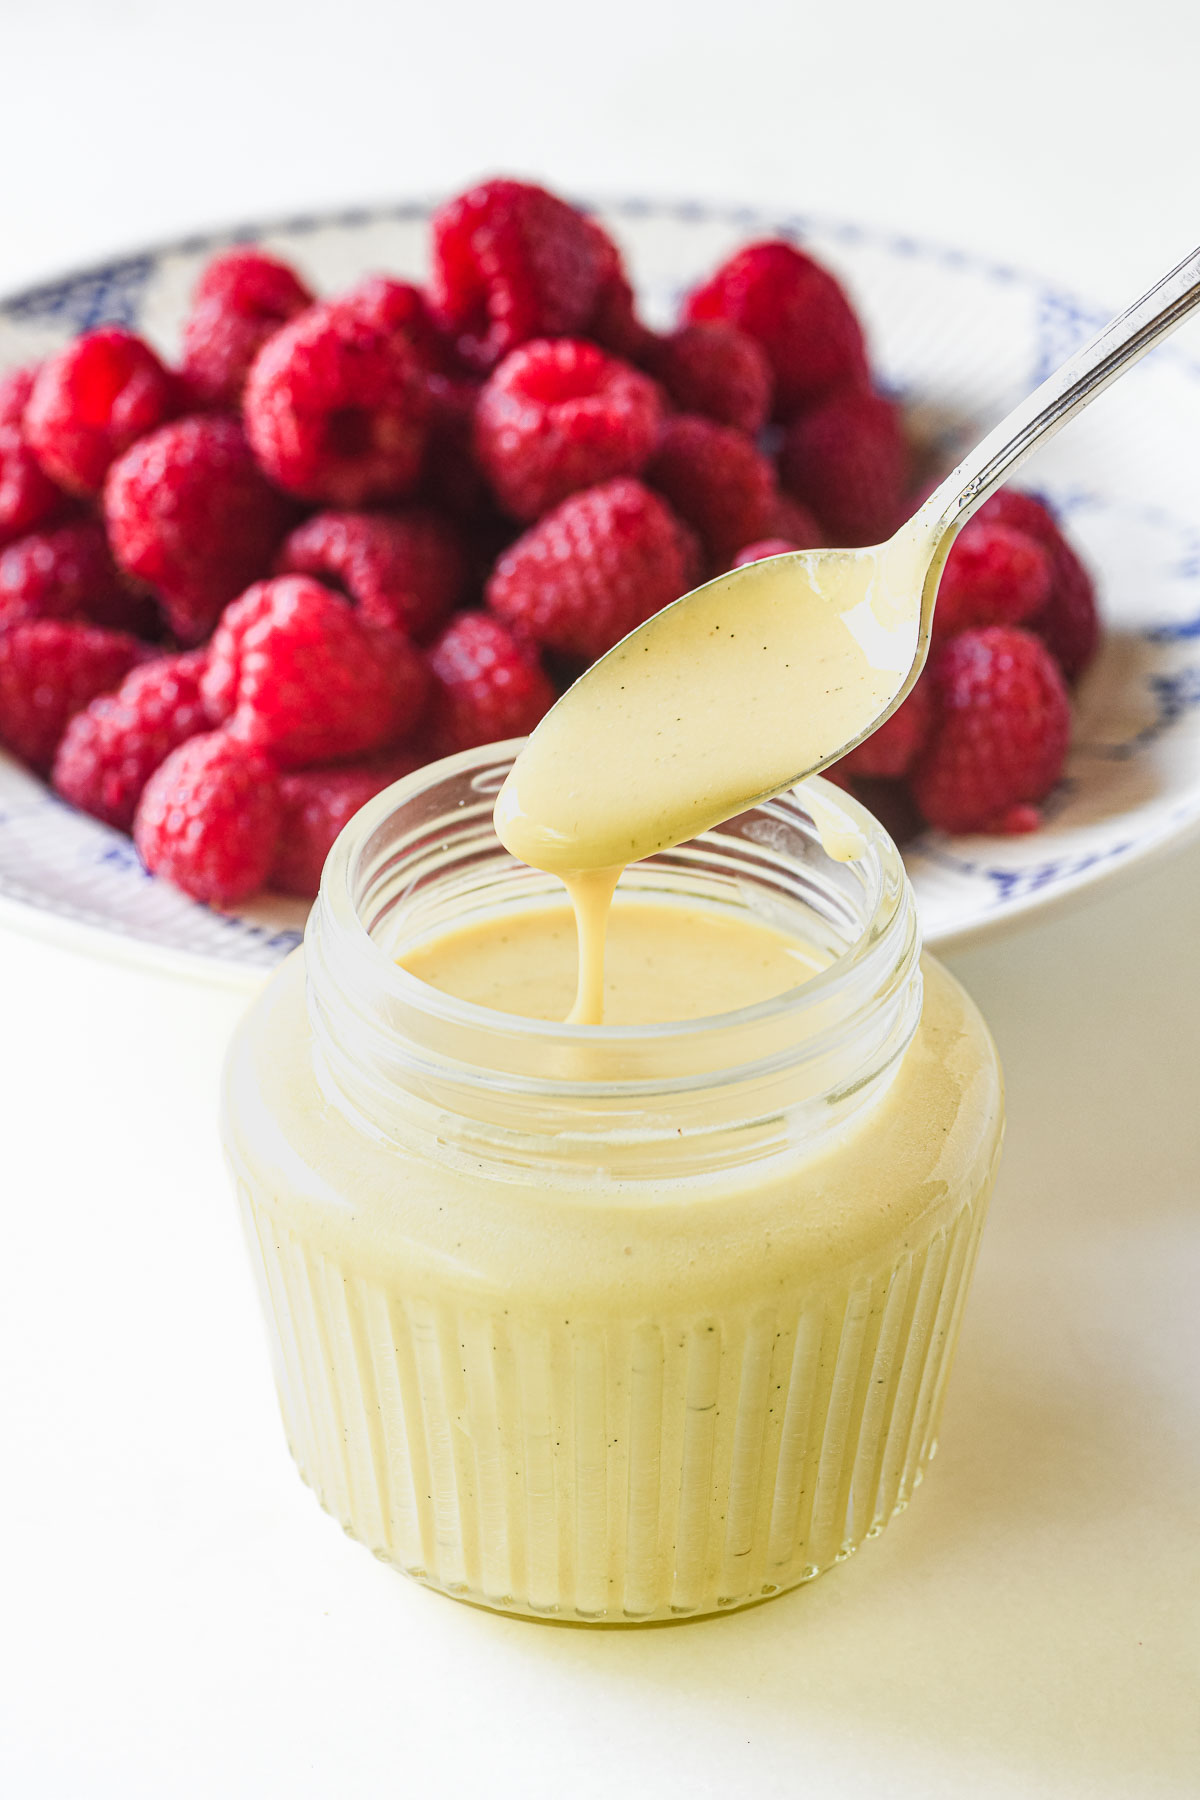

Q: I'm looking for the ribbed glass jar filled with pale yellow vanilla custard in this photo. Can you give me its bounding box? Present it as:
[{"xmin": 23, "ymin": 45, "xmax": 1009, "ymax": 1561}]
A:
[{"xmin": 223, "ymin": 745, "xmax": 1002, "ymax": 1624}]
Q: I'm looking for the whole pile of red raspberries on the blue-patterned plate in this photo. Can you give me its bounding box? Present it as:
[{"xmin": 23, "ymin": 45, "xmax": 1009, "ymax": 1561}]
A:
[{"xmin": 0, "ymin": 180, "xmax": 1097, "ymax": 905}]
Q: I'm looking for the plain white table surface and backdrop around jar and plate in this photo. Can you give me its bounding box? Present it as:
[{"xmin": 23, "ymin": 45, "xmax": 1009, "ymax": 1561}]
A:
[{"xmin": 0, "ymin": 0, "xmax": 1200, "ymax": 1800}]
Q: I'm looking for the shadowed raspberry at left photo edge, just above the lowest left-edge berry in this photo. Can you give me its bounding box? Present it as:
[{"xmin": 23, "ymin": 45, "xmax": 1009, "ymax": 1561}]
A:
[{"xmin": 0, "ymin": 518, "xmax": 143, "ymax": 630}]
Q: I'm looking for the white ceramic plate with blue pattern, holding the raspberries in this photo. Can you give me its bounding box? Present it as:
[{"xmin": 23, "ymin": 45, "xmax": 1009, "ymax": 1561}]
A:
[{"xmin": 0, "ymin": 200, "xmax": 1200, "ymax": 979}]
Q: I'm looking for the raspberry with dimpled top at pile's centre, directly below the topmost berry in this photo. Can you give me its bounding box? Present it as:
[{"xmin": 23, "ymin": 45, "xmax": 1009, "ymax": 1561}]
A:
[{"xmin": 475, "ymin": 338, "xmax": 660, "ymax": 518}]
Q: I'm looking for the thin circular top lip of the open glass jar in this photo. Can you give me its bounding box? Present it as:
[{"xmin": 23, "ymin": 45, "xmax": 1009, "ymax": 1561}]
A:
[{"xmin": 309, "ymin": 738, "xmax": 907, "ymax": 1048}]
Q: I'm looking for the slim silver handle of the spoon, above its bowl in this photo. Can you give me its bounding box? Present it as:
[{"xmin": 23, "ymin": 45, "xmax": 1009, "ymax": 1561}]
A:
[{"xmin": 923, "ymin": 250, "xmax": 1200, "ymax": 532}]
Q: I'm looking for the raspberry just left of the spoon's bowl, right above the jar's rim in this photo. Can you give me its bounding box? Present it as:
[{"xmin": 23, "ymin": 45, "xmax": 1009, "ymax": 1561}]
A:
[{"xmin": 430, "ymin": 612, "xmax": 554, "ymax": 756}]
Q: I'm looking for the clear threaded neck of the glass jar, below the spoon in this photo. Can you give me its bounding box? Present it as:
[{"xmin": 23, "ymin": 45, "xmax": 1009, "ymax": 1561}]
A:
[{"xmin": 306, "ymin": 740, "xmax": 921, "ymax": 1183}]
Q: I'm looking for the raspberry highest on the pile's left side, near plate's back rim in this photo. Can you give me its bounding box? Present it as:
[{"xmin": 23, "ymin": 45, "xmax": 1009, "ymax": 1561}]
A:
[{"xmin": 182, "ymin": 245, "xmax": 313, "ymax": 409}]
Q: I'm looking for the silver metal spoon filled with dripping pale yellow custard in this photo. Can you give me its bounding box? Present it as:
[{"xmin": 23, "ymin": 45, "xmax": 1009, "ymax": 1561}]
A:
[{"xmin": 497, "ymin": 250, "xmax": 1200, "ymax": 875}]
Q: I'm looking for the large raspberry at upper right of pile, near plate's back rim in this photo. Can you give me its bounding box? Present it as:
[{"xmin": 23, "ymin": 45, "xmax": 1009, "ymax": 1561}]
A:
[{"xmin": 684, "ymin": 241, "xmax": 867, "ymax": 419}]
